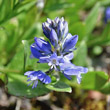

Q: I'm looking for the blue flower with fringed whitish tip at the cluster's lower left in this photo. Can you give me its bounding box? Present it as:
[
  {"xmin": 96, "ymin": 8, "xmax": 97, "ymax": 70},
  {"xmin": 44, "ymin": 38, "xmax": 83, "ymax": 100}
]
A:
[{"xmin": 24, "ymin": 71, "xmax": 51, "ymax": 88}]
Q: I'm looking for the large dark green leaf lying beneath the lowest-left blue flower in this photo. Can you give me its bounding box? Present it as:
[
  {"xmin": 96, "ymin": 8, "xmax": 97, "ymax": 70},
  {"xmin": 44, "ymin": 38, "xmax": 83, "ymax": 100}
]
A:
[{"xmin": 6, "ymin": 74, "xmax": 50, "ymax": 98}]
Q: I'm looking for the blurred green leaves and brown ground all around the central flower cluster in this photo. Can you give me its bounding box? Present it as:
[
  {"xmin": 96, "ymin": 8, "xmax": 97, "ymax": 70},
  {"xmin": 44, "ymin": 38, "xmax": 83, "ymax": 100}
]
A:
[{"xmin": 0, "ymin": 0, "xmax": 110, "ymax": 110}]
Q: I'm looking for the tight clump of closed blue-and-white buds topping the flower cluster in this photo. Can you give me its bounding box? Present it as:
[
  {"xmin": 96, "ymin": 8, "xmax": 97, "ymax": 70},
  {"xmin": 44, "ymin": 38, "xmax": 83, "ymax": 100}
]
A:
[{"xmin": 42, "ymin": 17, "xmax": 68, "ymax": 46}]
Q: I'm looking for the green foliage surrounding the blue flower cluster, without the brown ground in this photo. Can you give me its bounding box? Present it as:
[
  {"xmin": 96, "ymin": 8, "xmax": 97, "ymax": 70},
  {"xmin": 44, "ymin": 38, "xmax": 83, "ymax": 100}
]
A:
[{"xmin": 0, "ymin": 0, "xmax": 110, "ymax": 98}]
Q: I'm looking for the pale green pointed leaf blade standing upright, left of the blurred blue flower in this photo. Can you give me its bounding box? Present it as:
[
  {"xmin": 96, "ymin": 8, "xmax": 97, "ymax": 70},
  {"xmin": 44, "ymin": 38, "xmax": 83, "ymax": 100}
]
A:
[{"xmin": 85, "ymin": 2, "xmax": 100, "ymax": 35}]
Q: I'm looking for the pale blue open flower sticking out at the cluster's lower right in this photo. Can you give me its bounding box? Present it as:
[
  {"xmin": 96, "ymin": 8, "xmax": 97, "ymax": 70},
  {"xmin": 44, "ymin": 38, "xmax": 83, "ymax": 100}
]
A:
[{"xmin": 60, "ymin": 63, "xmax": 88, "ymax": 84}]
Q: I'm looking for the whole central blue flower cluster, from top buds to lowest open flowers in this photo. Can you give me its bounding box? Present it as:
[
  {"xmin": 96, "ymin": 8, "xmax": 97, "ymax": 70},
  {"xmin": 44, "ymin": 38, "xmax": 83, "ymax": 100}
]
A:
[{"xmin": 25, "ymin": 17, "xmax": 88, "ymax": 88}]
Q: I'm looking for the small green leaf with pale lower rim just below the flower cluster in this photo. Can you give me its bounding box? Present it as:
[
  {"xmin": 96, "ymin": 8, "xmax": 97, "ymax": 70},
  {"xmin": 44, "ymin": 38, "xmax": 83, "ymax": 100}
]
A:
[{"xmin": 46, "ymin": 81, "xmax": 72, "ymax": 93}]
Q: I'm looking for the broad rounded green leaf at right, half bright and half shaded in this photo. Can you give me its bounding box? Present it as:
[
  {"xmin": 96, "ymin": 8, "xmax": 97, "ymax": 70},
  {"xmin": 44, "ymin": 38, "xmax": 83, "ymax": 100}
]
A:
[{"xmin": 81, "ymin": 71, "xmax": 108, "ymax": 91}]
